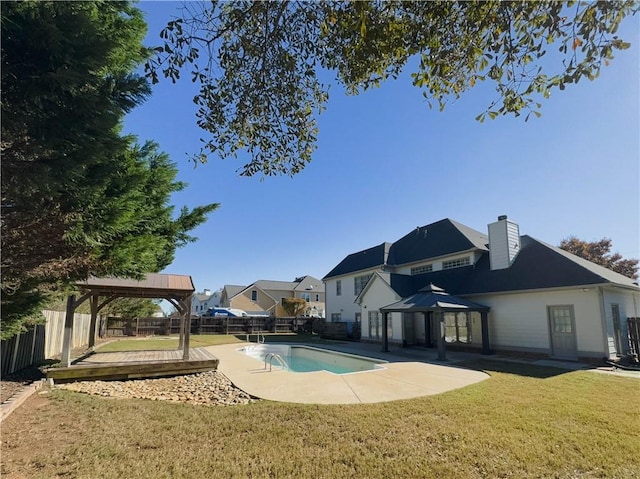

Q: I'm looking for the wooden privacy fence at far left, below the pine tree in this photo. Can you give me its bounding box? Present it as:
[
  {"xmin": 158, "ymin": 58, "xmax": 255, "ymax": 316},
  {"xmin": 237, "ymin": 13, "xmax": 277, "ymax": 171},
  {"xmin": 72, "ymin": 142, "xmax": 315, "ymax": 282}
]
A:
[{"xmin": 0, "ymin": 311, "xmax": 91, "ymax": 377}]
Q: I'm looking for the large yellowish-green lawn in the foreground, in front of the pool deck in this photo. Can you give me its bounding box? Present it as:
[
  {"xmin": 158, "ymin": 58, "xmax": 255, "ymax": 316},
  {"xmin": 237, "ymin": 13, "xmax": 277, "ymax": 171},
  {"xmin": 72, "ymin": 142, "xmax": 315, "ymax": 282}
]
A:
[{"xmin": 1, "ymin": 361, "xmax": 640, "ymax": 479}]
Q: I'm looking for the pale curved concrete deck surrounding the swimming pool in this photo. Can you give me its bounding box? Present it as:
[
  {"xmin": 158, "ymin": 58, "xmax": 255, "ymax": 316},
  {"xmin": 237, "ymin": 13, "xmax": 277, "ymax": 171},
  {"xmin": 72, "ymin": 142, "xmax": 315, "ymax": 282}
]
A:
[{"xmin": 206, "ymin": 343, "xmax": 489, "ymax": 404}]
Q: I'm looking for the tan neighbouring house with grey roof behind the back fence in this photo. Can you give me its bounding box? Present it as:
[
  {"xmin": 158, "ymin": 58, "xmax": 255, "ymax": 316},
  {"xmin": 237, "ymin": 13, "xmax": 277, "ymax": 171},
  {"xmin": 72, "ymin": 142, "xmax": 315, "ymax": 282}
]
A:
[{"xmin": 221, "ymin": 276, "xmax": 325, "ymax": 318}]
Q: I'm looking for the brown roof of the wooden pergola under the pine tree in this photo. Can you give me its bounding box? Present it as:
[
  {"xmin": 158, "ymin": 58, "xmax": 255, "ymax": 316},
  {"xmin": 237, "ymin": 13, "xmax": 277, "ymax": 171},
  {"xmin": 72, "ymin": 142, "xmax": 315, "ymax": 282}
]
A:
[{"xmin": 76, "ymin": 273, "xmax": 195, "ymax": 298}]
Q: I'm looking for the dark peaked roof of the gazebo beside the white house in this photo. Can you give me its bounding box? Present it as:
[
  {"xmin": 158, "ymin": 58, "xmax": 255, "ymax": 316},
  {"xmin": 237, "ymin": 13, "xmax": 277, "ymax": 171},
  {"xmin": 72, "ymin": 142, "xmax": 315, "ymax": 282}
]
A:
[{"xmin": 380, "ymin": 284, "xmax": 489, "ymax": 313}]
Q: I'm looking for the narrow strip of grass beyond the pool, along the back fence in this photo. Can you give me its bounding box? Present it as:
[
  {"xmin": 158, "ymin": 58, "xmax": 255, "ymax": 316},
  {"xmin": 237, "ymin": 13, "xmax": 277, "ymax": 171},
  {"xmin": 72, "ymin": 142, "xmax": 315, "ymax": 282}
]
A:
[{"xmin": 97, "ymin": 333, "xmax": 335, "ymax": 353}]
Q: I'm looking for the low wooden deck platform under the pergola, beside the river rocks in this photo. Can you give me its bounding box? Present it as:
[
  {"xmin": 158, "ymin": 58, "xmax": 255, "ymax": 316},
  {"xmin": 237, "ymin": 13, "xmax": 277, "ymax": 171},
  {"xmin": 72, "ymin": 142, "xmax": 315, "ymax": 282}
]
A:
[{"xmin": 47, "ymin": 348, "xmax": 219, "ymax": 383}]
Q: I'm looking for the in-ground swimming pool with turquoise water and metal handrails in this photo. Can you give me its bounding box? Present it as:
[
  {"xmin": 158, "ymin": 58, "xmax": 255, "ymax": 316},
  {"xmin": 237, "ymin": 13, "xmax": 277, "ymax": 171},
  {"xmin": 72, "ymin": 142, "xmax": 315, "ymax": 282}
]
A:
[{"xmin": 240, "ymin": 344, "xmax": 387, "ymax": 374}]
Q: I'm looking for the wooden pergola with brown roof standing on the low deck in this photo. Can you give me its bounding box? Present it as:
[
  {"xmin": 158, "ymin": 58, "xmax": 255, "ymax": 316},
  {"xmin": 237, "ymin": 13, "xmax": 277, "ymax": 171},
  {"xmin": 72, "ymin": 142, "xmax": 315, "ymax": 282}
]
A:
[{"xmin": 61, "ymin": 273, "xmax": 195, "ymax": 367}]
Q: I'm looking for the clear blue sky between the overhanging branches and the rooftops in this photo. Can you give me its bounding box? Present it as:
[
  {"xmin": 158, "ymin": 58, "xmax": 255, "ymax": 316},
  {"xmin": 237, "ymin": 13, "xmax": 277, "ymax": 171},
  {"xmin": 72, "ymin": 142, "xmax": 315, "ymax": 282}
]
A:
[{"xmin": 124, "ymin": 2, "xmax": 640, "ymax": 291}]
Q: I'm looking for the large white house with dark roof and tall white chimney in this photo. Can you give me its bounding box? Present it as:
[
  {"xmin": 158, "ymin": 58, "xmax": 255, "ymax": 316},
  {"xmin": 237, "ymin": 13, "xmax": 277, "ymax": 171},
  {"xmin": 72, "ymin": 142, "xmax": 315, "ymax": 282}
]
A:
[{"xmin": 323, "ymin": 216, "xmax": 640, "ymax": 359}]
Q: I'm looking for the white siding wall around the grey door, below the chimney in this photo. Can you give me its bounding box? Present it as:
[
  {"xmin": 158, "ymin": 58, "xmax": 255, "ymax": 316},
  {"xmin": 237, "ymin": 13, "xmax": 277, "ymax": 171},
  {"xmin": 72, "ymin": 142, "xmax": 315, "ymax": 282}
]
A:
[{"xmin": 470, "ymin": 288, "xmax": 606, "ymax": 357}]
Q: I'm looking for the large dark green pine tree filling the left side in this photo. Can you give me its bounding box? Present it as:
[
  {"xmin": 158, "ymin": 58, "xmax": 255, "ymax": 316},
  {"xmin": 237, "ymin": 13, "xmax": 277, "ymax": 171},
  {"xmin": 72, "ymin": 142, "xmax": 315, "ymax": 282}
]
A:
[{"xmin": 1, "ymin": 1, "xmax": 217, "ymax": 338}]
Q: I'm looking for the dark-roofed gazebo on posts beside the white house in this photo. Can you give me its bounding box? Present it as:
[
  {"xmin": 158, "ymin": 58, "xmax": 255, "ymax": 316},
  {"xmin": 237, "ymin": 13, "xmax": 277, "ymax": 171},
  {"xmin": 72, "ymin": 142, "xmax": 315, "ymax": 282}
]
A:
[{"xmin": 380, "ymin": 284, "xmax": 491, "ymax": 360}]
